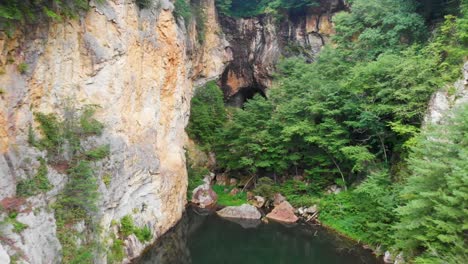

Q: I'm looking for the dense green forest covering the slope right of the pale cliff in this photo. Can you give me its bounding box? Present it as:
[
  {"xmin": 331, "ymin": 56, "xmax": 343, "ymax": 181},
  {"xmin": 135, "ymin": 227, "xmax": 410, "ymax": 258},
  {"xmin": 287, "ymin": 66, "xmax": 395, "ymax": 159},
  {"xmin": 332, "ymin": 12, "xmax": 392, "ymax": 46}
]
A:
[{"xmin": 188, "ymin": 0, "xmax": 468, "ymax": 263}]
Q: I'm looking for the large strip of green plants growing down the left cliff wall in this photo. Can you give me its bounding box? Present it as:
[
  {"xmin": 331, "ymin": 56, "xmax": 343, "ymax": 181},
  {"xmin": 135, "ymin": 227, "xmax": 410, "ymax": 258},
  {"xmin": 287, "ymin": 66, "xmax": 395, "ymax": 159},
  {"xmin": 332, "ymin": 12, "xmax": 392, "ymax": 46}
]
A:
[{"xmin": 28, "ymin": 106, "xmax": 110, "ymax": 263}]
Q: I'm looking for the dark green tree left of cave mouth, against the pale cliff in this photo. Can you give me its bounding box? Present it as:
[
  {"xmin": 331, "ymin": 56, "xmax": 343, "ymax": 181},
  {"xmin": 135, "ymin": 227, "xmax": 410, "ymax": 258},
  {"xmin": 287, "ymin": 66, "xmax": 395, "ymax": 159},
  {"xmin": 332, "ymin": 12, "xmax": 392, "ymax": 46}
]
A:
[{"xmin": 187, "ymin": 81, "xmax": 227, "ymax": 150}]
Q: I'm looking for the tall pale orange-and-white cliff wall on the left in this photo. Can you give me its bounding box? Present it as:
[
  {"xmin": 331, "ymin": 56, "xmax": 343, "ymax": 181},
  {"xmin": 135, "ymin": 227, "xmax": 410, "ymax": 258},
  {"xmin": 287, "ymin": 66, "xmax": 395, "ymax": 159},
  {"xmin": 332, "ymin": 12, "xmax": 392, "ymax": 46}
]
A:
[{"xmin": 0, "ymin": 0, "xmax": 227, "ymax": 264}]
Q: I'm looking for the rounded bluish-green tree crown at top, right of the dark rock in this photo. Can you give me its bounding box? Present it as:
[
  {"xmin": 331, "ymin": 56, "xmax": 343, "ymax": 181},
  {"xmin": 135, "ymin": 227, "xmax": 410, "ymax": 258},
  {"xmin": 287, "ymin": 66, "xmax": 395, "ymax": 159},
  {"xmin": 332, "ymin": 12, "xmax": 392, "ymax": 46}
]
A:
[{"xmin": 334, "ymin": 0, "xmax": 427, "ymax": 59}]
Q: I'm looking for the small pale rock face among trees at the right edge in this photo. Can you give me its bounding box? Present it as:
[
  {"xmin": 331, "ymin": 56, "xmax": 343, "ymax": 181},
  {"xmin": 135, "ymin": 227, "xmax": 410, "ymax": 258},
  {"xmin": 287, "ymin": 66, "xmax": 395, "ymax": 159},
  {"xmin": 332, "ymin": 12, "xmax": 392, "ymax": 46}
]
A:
[{"xmin": 424, "ymin": 62, "xmax": 468, "ymax": 124}]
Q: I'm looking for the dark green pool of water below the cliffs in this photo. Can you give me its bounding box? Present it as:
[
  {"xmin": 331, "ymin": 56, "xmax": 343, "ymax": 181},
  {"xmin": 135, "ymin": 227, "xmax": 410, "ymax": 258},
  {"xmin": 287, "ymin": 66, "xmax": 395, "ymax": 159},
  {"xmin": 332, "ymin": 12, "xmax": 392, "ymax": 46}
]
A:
[{"xmin": 134, "ymin": 208, "xmax": 380, "ymax": 264}]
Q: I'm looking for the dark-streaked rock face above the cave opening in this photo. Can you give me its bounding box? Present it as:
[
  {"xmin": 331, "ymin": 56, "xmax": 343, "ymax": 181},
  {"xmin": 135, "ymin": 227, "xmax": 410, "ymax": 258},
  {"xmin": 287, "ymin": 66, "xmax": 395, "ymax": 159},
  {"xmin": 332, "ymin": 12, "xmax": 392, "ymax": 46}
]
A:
[{"xmin": 220, "ymin": 0, "xmax": 346, "ymax": 106}]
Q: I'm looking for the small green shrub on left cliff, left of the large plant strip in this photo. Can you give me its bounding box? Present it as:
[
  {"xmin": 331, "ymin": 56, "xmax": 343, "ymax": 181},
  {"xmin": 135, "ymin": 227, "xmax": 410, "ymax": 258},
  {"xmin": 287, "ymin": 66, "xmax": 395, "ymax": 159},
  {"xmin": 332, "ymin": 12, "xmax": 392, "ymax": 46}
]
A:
[{"xmin": 16, "ymin": 158, "xmax": 52, "ymax": 197}]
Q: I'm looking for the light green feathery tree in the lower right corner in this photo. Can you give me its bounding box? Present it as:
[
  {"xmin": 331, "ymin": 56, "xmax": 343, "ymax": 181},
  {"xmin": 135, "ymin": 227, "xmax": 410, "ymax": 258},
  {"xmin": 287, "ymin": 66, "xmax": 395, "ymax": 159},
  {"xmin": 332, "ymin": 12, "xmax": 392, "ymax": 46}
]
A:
[{"xmin": 395, "ymin": 106, "xmax": 468, "ymax": 263}]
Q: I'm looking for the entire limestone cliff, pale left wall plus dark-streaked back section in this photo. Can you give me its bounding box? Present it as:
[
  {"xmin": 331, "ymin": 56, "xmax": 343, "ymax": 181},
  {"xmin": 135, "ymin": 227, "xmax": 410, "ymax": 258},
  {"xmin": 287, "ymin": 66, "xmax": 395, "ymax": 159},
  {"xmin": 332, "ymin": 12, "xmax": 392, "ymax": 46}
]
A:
[{"xmin": 0, "ymin": 0, "xmax": 345, "ymax": 264}]
